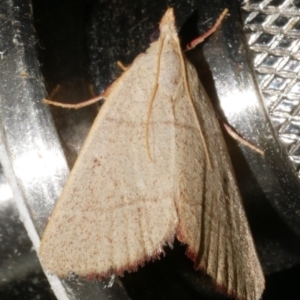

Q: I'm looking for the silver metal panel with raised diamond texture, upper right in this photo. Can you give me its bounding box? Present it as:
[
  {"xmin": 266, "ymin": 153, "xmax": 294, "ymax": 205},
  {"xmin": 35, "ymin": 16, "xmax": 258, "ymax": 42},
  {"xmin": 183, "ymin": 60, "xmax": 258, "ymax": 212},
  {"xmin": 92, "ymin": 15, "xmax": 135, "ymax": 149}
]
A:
[{"xmin": 244, "ymin": 0, "xmax": 300, "ymax": 177}]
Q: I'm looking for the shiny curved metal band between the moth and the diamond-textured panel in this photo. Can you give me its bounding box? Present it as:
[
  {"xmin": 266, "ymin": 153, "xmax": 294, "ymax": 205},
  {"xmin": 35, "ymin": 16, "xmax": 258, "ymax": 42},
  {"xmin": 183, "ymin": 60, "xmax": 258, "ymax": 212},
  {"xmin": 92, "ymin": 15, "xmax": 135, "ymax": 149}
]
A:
[{"xmin": 200, "ymin": 1, "xmax": 300, "ymax": 237}]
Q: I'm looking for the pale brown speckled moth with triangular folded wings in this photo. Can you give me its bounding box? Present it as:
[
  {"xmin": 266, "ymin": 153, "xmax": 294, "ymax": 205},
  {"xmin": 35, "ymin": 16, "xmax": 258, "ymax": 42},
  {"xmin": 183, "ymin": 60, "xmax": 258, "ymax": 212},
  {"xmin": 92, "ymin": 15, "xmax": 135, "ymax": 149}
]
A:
[{"xmin": 40, "ymin": 9, "xmax": 264, "ymax": 300}]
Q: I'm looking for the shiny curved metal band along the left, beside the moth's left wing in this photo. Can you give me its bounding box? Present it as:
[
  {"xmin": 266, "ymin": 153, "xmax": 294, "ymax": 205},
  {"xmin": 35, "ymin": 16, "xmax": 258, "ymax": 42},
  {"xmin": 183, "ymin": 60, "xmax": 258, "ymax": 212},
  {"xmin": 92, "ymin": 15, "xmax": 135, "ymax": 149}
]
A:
[{"xmin": 0, "ymin": 0, "xmax": 127, "ymax": 299}]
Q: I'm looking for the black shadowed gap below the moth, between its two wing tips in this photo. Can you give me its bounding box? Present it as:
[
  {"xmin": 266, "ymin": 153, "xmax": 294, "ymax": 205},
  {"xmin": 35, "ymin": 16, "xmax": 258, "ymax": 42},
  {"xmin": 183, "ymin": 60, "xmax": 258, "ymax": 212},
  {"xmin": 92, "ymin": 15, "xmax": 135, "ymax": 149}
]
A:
[{"xmin": 121, "ymin": 240, "xmax": 229, "ymax": 300}]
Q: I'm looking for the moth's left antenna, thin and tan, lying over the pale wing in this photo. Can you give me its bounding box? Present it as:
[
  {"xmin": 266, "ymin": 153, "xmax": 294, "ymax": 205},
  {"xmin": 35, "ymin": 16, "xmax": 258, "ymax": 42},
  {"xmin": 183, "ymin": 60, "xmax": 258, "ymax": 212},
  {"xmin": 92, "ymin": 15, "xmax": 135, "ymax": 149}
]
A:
[{"xmin": 146, "ymin": 37, "xmax": 165, "ymax": 161}]
